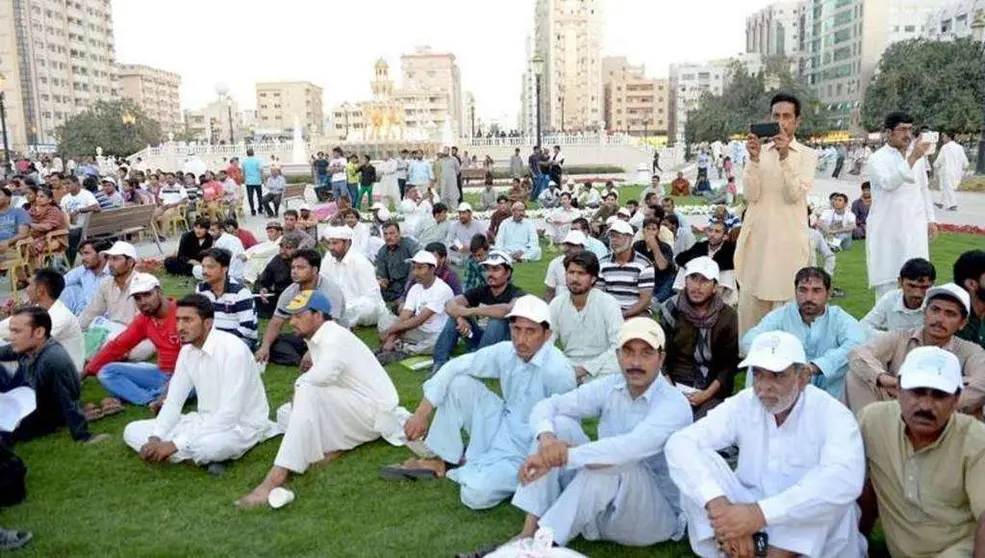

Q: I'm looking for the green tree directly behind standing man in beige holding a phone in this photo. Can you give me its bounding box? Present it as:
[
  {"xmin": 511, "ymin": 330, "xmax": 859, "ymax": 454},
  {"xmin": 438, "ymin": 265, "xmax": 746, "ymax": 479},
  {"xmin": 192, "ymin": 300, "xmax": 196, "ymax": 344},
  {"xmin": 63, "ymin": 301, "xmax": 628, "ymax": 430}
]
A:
[{"xmin": 684, "ymin": 59, "xmax": 826, "ymax": 143}]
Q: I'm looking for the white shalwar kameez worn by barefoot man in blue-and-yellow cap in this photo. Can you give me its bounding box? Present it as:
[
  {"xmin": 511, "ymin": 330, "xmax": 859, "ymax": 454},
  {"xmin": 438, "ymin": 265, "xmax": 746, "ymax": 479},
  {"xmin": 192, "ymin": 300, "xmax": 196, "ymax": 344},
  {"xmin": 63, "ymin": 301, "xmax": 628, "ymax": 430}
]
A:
[{"xmin": 274, "ymin": 321, "xmax": 407, "ymax": 473}]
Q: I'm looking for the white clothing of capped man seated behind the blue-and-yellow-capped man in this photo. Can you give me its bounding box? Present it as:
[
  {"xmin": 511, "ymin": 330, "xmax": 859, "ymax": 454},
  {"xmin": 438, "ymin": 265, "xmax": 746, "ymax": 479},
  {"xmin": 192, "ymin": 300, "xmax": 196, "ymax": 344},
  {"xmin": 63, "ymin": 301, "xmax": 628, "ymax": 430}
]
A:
[{"xmin": 320, "ymin": 249, "xmax": 386, "ymax": 326}]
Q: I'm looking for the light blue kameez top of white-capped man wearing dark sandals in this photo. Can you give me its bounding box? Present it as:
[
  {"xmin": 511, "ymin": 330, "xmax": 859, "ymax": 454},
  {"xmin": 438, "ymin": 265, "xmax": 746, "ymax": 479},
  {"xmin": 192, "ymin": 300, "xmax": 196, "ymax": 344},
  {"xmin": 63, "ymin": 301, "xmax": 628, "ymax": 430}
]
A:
[{"xmin": 424, "ymin": 341, "xmax": 577, "ymax": 468}]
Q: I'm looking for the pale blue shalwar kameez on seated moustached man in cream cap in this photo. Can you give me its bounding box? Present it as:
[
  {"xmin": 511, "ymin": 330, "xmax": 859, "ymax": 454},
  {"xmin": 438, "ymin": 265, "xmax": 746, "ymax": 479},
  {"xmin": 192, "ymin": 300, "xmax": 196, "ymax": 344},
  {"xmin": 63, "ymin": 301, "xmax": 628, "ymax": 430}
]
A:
[{"xmin": 513, "ymin": 375, "xmax": 692, "ymax": 546}]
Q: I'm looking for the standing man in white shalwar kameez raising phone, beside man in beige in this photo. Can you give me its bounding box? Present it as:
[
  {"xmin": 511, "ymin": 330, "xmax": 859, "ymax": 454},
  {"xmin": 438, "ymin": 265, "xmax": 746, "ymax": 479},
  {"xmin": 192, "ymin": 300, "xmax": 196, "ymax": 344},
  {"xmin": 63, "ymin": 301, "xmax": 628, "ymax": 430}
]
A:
[{"xmin": 865, "ymin": 112, "xmax": 937, "ymax": 300}]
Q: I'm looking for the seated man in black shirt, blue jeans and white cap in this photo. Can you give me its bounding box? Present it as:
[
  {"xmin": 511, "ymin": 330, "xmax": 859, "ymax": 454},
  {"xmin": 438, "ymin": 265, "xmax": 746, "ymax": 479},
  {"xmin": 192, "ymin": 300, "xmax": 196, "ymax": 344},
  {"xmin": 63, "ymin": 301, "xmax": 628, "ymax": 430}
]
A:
[{"xmin": 434, "ymin": 250, "xmax": 525, "ymax": 371}]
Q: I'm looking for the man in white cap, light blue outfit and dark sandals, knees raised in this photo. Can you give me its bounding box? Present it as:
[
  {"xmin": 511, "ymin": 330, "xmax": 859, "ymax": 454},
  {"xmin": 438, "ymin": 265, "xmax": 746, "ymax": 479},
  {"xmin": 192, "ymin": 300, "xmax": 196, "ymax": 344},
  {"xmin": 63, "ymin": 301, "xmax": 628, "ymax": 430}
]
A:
[{"xmin": 380, "ymin": 295, "xmax": 575, "ymax": 510}]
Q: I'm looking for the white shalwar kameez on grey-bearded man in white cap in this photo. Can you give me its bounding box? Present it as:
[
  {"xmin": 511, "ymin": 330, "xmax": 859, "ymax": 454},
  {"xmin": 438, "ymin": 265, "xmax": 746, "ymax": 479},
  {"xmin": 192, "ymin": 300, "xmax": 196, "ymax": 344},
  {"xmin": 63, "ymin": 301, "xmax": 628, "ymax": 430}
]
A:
[{"xmin": 664, "ymin": 385, "xmax": 866, "ymax": 558}]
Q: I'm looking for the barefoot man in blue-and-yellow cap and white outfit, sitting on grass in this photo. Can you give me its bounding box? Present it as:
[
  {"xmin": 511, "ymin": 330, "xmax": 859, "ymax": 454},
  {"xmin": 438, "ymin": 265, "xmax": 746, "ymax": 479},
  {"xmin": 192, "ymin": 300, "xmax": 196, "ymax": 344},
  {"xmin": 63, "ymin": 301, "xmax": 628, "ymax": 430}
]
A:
[{"xmin": 238, "ymin": 290, "xmax": 406, "ymax": 506}]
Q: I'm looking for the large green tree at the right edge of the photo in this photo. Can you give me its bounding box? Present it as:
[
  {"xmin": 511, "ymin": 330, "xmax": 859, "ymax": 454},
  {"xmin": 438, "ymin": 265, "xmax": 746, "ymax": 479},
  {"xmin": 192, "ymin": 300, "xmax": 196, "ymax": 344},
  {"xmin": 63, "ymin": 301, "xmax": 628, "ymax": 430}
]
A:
[{"xmin": 862, "ymin": 39, "xmax": 985, "ymax": 133}]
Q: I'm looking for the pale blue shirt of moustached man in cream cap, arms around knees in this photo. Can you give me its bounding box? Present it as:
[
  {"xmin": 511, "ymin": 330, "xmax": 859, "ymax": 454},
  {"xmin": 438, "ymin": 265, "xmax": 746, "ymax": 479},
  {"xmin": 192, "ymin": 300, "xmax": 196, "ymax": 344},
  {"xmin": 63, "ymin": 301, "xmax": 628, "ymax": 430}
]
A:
[{"xmin": 530, "ymin": 374, "xmax": 693, "ymax": 470}]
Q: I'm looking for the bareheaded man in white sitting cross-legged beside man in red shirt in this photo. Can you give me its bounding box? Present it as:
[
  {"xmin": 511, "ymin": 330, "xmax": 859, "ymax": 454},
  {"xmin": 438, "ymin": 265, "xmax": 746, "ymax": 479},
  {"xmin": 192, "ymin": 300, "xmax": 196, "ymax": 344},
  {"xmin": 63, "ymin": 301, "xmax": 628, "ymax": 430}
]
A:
[{"xmin": 123, "ymin": 294, "xmax": 280, "ymax": 465}]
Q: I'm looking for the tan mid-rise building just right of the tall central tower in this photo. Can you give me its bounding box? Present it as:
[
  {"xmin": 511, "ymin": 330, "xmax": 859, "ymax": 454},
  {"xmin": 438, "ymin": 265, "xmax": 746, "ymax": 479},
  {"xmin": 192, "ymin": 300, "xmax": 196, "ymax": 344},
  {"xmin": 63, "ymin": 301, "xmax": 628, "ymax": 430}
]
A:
[{"xmin": 602, "ymin": 56, "xmax": 670, "ymax": 136}]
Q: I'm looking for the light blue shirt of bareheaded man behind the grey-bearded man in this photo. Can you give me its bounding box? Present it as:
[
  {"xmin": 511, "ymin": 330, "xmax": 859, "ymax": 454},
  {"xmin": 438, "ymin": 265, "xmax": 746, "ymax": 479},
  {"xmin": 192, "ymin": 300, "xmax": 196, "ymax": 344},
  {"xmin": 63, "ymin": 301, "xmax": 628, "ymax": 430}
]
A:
[{"xmin": 739, "ymin": 301, "xmax": 865, "ymax": 401}]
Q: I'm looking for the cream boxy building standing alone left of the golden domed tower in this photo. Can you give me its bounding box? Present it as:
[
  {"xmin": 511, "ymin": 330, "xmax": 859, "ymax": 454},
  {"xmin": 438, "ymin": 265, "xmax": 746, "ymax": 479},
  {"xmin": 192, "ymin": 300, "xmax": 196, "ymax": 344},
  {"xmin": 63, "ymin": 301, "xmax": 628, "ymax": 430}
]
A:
[{"xmin": 256, "ymin": 81, "xmax": 325, "ymax": 138}]
